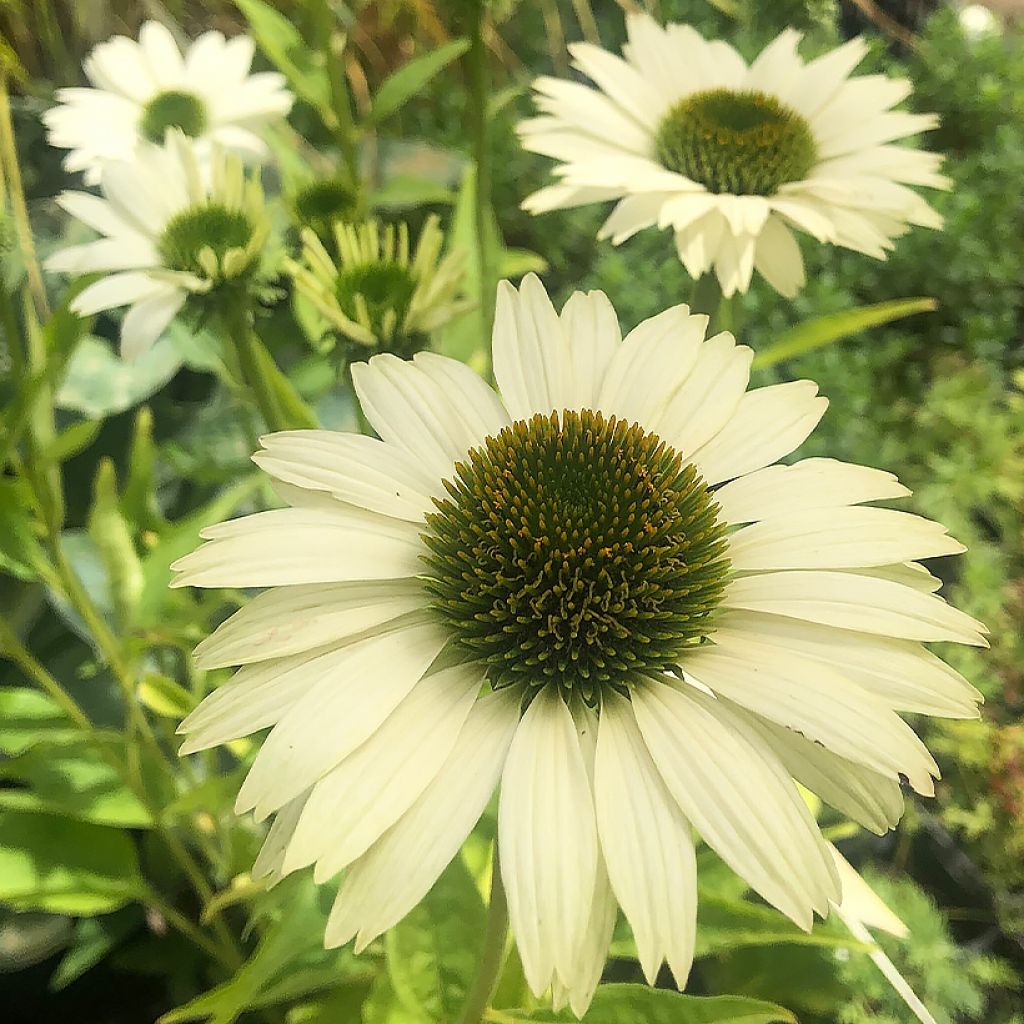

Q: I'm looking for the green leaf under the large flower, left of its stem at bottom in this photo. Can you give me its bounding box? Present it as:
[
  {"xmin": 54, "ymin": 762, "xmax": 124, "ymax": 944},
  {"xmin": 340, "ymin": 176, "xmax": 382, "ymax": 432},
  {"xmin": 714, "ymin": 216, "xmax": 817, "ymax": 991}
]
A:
[{"xmin": 385, "ymin": 857, "xmax": 486, "ymax": 1021}]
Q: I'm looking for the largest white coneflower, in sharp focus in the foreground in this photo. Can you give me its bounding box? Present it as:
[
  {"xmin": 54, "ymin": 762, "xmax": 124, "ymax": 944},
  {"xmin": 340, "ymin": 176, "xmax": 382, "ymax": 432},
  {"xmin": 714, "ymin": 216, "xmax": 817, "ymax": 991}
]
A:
[{"xmin": 174, "ymin": 276, "xmax": 985, "ymax": 1015}]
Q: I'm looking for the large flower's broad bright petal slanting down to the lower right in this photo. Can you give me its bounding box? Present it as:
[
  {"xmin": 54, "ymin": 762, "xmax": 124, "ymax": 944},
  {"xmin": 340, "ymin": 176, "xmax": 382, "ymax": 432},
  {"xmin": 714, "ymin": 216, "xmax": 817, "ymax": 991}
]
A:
[{"xmin": 633, "ymin": 681, "xmax": 839, "ymax": 930}]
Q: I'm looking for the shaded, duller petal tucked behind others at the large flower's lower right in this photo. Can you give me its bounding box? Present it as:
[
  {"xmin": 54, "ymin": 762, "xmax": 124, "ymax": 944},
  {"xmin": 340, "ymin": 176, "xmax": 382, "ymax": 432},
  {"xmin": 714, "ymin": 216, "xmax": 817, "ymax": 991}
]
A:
[{"xmin": 736, "ymin": 707, "xmax": 903, "ymax": 835}]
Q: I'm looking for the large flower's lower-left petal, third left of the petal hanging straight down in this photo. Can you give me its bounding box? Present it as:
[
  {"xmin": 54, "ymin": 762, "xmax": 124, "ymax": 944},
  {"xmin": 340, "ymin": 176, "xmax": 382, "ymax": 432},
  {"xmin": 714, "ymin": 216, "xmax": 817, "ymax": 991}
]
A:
[{"xmin": 234, "ymin": 623, "xmax": 446, "ymax": 818}]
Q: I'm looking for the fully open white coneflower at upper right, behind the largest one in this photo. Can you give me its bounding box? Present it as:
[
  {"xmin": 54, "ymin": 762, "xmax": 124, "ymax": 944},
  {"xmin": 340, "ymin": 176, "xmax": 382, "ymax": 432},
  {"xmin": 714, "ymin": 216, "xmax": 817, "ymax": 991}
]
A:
[{"xmin": 519, "ymin": 14, "xmax": 949, "ymax": 296}]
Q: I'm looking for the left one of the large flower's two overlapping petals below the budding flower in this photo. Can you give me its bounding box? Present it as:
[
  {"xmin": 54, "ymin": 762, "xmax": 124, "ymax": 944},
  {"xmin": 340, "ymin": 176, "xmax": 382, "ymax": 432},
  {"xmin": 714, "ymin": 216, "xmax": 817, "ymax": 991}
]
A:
[{"xmin": 352, "ymin": 353, "xmax": 482, "ymax": 478}]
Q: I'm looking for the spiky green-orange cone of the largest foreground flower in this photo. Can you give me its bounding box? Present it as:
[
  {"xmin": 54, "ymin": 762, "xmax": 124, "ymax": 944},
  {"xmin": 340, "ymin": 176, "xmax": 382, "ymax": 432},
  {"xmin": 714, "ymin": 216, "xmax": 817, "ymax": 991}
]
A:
[{"xmin": 424, "ymin": 410, "xmax": 729, "ymax": 703}]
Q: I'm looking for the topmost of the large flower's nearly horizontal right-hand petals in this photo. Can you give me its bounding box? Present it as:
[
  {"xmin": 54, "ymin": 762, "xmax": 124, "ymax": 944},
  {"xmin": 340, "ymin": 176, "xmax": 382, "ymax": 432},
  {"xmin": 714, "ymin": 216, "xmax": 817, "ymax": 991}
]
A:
[{"xmin": 715, "ymin": 459, "xmax": 910, "ymax": 523}]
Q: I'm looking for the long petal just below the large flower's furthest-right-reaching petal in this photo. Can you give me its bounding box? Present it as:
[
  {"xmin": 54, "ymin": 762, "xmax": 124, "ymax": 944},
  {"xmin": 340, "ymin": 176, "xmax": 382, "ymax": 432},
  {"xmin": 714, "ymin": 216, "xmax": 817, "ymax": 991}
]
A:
[{"xmin": 715, "ymin": 611, "xmax": 982, "ymax": 718}]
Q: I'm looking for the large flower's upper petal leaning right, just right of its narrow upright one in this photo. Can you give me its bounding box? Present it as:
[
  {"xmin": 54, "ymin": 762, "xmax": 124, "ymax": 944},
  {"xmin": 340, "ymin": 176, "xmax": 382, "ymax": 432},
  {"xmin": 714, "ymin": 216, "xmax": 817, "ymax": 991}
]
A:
[{"xmin": 597, "ymin": 306, "xmax": 708, "ymax": 429}]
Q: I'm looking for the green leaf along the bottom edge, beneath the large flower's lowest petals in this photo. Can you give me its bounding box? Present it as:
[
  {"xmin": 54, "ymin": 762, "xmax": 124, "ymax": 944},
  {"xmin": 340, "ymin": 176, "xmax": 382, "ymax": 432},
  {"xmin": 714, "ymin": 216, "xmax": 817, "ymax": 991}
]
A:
[{"xmin": 502, "ymin": 985, "xmax": 797, "ymax": 1024}]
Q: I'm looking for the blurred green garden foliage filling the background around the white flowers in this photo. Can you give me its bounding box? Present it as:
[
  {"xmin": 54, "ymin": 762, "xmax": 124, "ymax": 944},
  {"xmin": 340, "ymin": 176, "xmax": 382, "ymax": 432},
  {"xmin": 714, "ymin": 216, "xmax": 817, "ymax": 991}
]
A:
[{"xmin": 0, "ymin": 0, "xmax": 1024, "ymax": 1024}]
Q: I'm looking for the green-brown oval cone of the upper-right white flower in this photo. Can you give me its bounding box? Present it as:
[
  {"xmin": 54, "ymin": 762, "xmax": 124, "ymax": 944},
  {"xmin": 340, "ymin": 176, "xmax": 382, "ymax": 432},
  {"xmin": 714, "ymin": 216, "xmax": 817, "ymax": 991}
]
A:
[{"xmin": 654, "ymin": 89, "xmax": 817, "ymax": 196}]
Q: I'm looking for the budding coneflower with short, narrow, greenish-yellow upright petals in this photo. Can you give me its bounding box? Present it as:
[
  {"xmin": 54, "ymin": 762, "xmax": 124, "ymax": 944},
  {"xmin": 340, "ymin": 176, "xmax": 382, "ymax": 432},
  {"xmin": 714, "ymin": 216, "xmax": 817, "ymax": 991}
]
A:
[{"xmin": 290, "ymin": 215, "xmax": 469, "ymax": 355}]
